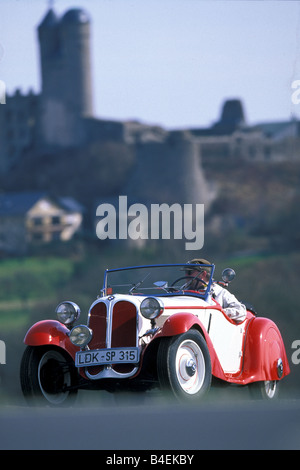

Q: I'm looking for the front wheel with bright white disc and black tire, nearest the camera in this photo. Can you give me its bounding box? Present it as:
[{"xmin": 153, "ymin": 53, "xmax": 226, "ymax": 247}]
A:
[{"xmin": 157, "ymin": 330, "xmax": 211, "ymax": 402}]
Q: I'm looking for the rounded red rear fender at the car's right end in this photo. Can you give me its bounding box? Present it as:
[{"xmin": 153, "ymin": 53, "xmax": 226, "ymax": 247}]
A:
[{"xmin": 239, "ymin": 317, "xmax": 290, "ymax": 383}]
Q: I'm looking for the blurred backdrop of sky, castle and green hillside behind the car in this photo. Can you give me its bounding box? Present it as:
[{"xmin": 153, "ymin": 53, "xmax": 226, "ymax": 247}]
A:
[{"xmin": 0, "ymin": 0, "xmax": 300, "ymax": 403}]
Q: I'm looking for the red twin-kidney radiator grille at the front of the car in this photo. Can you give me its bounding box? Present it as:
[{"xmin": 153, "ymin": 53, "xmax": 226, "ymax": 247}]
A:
[{"xmin": 88, "ymin": 299, "xmax": 137, "ymax": 375}]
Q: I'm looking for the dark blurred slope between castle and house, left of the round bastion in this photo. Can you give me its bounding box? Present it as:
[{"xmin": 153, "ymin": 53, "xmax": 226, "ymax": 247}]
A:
[{"xmin": 0, "ymin": 142, "xmax": 135, "ymax": 206}]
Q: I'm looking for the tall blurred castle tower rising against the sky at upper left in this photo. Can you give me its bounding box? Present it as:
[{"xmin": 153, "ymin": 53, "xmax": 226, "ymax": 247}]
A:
[{"xmin": 38, "ymin": 8, "xmax": 93, "ymax": 147}]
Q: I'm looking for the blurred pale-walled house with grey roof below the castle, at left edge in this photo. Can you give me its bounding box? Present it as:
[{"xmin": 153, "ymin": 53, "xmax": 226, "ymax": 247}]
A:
[{"xmin": 0, "ymin": 192, "xmax": 83, "ymax": 254}]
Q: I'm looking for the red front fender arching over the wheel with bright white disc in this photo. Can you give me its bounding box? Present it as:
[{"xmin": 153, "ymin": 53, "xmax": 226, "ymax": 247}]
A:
[{"xmin": 155, "ymin": 312, "xmax": 226, "ymax": 380}]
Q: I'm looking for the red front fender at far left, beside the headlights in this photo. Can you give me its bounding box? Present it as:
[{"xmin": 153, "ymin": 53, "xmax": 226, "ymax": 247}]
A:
[{"xmin": 24, "ymin": 320, "xmax": 80, "ymax": 360}]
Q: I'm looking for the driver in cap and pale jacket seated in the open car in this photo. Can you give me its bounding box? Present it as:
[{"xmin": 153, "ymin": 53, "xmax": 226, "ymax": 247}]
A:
[{"xmin": 187, "ymin": 258, "xmax": 246, "ymax": 323}]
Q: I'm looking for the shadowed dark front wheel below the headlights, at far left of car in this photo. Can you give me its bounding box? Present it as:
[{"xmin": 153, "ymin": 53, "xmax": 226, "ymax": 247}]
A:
[{"xmin": 20, "ymin": 346, "xmax": 77, "ymax": 406}]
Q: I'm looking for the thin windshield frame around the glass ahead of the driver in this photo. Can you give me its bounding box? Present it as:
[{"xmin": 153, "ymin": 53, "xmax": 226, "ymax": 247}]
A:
[{"xmin": 101, "ymin": 263, "xmax": 215, "ymax": 300}]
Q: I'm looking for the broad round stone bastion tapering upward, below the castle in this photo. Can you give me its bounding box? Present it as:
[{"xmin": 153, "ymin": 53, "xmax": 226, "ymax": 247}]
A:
[{"xmin": 124, "ymin": 132, "xmax": 212, "ymax": 204}]
